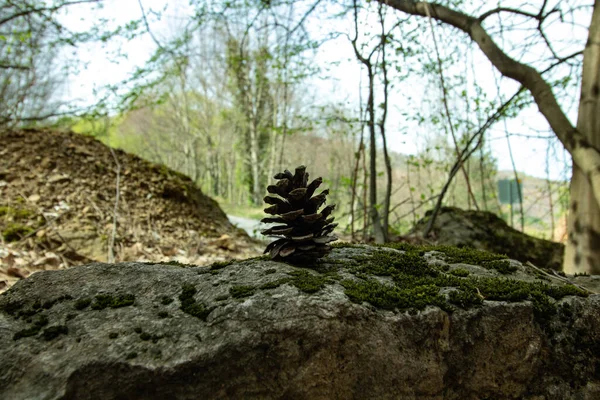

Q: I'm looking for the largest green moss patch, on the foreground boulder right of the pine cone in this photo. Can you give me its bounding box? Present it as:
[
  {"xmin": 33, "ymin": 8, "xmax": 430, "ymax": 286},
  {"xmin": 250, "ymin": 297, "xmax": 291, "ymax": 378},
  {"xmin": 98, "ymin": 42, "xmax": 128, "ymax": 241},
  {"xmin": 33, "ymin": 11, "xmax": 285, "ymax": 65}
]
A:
[{"xmin": 342, "ymin": 244, "xmax": 587, "ymax": 323}]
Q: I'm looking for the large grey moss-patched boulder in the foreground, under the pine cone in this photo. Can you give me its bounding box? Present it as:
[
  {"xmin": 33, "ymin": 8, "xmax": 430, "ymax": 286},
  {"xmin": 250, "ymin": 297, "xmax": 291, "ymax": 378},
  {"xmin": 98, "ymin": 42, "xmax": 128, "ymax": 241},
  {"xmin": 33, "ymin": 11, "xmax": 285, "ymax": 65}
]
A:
[{"xmin": 0, "ymin": 245, "xmax": 600, "ymax": 400}]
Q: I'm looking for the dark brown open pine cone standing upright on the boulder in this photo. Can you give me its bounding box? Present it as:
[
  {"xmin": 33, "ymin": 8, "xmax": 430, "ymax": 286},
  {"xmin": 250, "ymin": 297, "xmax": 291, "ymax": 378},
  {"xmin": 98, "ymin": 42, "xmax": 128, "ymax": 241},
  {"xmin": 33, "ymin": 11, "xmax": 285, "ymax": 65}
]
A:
[{"xmin": 261, "ymin": 165, "xmax": 337, "ymax": 260}]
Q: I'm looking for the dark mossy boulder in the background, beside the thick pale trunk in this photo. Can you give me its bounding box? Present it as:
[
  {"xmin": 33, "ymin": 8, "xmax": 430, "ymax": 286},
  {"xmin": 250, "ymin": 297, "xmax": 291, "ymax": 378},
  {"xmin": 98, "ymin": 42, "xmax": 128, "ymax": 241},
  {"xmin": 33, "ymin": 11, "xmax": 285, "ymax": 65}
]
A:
[{"xmin": 411, "ymin": 207, "xmax": 565, "ymax": 271}]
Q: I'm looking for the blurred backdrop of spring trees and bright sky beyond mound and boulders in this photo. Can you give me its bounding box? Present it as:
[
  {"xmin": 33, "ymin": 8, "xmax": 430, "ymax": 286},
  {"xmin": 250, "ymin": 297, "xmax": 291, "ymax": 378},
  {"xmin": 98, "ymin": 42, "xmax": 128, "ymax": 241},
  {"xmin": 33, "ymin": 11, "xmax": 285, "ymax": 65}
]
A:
[{"xmin": 0, "ymin": 0, "xmax": 593, "ymax": 250}]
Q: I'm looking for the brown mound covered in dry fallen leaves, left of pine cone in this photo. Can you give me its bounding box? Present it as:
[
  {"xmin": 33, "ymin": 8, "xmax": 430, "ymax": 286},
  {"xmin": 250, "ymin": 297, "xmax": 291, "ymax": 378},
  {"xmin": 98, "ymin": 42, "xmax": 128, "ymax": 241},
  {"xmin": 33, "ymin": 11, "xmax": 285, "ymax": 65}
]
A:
[{"xmin": 0, "ymin": 129, "xmax": 264, "ymax": 292}]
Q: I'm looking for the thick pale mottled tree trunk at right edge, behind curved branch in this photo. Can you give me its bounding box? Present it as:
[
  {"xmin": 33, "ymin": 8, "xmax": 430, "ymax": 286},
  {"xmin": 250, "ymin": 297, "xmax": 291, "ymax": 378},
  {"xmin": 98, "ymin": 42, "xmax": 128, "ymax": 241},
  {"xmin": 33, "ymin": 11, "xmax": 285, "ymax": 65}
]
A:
[{"xmin": 563, "ymin": 0, "xmax": 600, "ymax": 274}]
